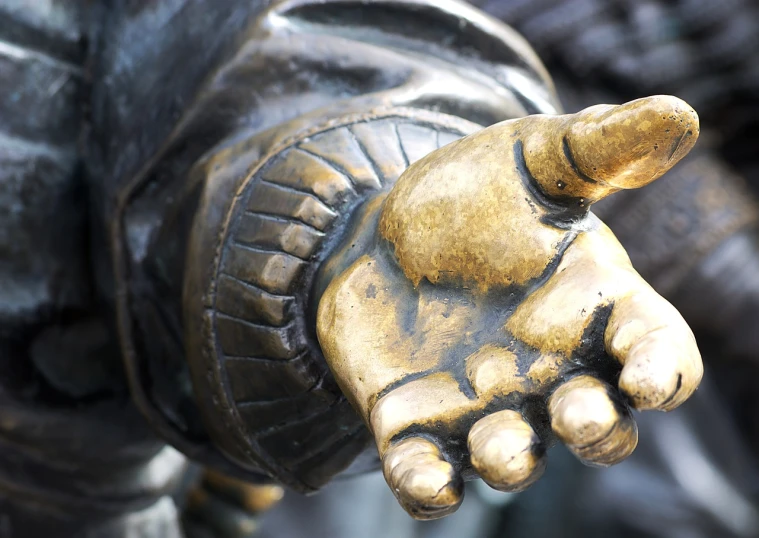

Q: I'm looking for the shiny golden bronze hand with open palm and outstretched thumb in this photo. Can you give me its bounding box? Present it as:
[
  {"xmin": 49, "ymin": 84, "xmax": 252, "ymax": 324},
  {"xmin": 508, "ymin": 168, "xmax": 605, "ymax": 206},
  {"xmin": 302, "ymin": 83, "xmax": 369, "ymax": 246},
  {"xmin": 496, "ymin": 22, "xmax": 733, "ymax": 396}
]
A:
[{"xmin": 317, "ymin": 96, "xmax": 703, "ymax": 518}]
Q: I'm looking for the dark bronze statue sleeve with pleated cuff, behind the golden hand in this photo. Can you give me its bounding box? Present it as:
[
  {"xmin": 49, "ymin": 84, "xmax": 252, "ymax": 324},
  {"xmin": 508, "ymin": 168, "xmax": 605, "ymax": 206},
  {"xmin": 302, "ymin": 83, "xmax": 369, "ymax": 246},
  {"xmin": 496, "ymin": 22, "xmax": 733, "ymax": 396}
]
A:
[{"xmin": 91, "ymin": 0, "xmax": 558, "ymax": 491}]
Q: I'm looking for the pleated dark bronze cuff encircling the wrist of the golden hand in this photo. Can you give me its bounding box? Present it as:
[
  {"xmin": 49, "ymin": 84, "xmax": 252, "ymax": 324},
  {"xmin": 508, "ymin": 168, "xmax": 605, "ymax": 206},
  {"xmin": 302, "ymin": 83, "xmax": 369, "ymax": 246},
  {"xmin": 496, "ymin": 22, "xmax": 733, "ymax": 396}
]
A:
[{"xmin": 185, "ymin": 108, "xmax": 484, "ymax": 489}]
